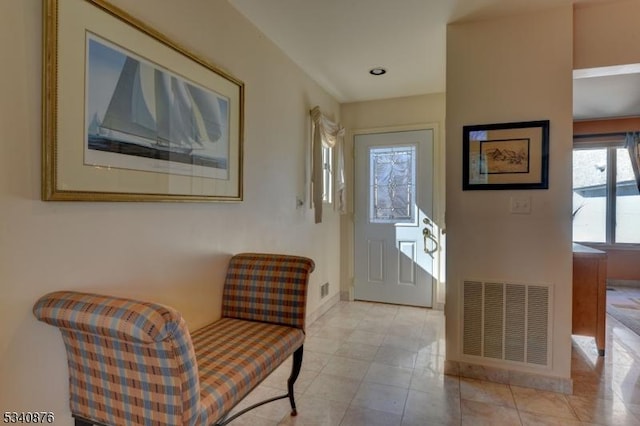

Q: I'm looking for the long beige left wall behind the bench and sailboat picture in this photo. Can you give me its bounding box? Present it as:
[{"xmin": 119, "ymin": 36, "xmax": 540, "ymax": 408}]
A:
[{"xmin": 0, "ymin": 0, "xmax": 340, "ymax": 425}]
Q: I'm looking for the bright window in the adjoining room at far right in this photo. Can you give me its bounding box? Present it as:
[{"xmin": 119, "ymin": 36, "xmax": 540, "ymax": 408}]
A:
[{"xmin": 573, "ymin": 145, "xmax": 640, "ymax": 244}]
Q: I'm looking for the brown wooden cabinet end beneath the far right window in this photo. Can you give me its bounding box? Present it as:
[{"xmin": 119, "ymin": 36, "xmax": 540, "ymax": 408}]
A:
[{"xmin": 572, "ymin": 244, "xmax": 607, "ymax": 356}]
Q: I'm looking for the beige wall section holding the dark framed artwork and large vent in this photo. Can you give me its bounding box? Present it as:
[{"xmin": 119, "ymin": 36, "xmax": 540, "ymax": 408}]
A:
[{"xmin": 445, "ymin": 6, "xmax": 572, "ymax": 378}]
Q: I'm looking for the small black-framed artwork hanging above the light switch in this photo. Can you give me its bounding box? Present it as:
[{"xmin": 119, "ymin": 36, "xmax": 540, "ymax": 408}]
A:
[{"xmin": 462, "ymin": 120, "xmax": 549, "ymax": 191}]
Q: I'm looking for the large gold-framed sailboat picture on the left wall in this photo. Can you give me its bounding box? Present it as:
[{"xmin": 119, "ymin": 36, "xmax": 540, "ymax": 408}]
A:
[{"xmin": 42, "ymin": 0, "xmax": 244, "ymax": 201}]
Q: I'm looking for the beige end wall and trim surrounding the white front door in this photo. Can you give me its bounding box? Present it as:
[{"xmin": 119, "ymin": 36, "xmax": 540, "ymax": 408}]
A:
[{"xmin": 341, "ymin": 93, "xmax": 445, "ymax": 309}]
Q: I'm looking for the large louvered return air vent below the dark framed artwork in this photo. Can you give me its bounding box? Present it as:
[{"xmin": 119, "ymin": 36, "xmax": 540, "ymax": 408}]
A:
[{"xmin": 462, "ymin": 281, "xmax": 552, "ymax": 366}]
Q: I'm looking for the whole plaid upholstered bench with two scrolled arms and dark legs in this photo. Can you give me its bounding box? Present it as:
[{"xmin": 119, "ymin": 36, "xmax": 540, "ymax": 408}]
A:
[{"xmin": 33, "ymin": 253, "xmax": 314, "ymax": 426}]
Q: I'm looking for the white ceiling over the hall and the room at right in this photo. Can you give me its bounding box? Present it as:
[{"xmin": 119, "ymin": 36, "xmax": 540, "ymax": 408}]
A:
[{"xmin": 229, "ymin": 0, "xmax": 640, "ymax": 119}]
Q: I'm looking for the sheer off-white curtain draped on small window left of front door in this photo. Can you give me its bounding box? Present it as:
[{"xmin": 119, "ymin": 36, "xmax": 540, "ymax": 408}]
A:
[{"xmin": 311, "ymin": 107, "xmax": 346, "ymax": 223}]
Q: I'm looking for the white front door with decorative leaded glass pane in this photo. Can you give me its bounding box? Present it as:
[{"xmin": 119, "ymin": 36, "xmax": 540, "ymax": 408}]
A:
[{"xmin": 354, "ymin": 129, "xmax": 437, "ymax": 307}]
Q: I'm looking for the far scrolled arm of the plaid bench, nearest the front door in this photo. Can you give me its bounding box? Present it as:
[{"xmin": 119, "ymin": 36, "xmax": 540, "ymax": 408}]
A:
[{"xmin": 222, "ymin": 253, "xmax": 314, "ymax": 329}]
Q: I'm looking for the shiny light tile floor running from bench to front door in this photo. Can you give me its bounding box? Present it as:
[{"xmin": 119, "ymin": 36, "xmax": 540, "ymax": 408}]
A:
[{"xmin": 231, "ymin": 296, "xmax": 640, "ymax": 426}]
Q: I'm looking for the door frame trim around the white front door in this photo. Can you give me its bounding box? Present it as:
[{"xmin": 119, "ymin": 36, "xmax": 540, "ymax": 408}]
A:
[{"xmin": 340, "ymin": 122, "xmax": 446, "ymax": 310}]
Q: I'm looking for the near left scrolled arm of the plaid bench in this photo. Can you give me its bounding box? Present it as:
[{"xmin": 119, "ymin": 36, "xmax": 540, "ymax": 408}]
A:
[{"xmin": 33, "ymin": 291, "xmax": 201, "ymax": 425}]
